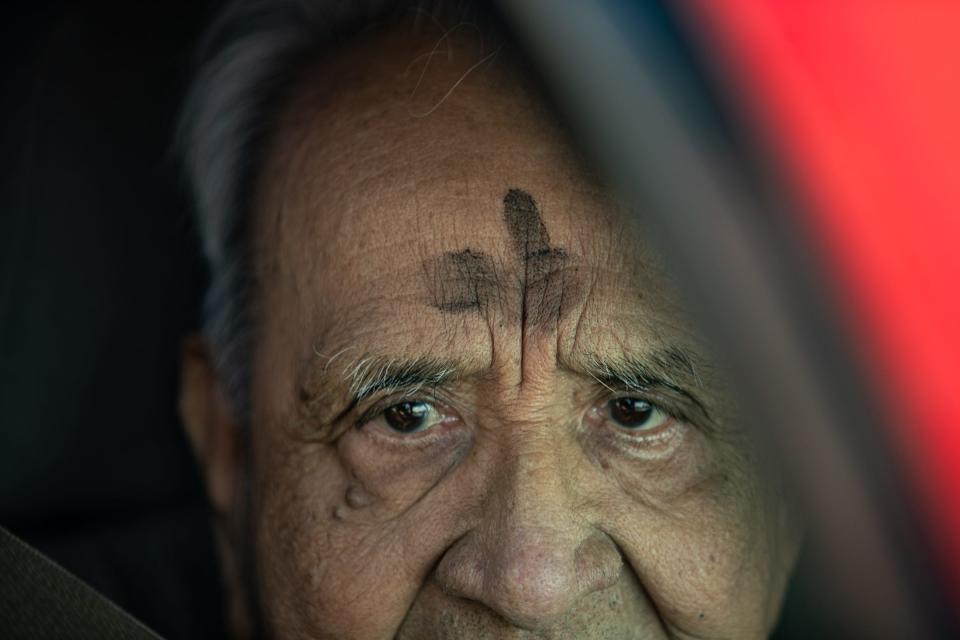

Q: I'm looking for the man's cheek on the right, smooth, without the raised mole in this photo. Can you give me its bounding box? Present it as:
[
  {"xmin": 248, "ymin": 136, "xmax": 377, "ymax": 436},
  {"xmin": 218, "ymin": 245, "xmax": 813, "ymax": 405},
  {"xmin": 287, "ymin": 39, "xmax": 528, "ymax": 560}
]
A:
[{"xmin": 600, "ymin": 429, "xmax": 780, "ymax": 638}]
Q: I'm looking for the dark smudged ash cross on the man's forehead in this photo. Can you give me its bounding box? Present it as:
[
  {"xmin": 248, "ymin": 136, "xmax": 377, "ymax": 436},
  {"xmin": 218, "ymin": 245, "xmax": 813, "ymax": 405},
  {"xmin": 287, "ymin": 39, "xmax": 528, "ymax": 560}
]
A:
[{"xmin": 423, "ymin": 188, "xmax": 583, "ymax": 328}]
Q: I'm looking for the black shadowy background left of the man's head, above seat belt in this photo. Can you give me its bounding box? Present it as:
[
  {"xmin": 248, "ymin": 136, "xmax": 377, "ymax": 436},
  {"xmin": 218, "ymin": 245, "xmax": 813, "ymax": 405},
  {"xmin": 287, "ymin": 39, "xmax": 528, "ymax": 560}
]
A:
[{"xmin": 0, "ymin": 0, "xmax": 222, "ymax": 638}]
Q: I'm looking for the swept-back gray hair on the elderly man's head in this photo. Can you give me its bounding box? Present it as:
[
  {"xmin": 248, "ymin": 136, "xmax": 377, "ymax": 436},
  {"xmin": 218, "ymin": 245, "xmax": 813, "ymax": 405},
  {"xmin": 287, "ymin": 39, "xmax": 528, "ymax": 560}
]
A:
[{"xmin": 180, "ymin": 0, "xmax": 496, "ymax": 420}]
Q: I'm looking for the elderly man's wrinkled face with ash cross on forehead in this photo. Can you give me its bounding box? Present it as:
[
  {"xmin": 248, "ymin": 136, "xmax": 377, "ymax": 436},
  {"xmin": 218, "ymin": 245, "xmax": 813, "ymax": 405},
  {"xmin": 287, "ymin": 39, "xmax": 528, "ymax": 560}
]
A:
[{"xmin": 185, "ymin": 26, "xmax": 797, "ymax": 639}]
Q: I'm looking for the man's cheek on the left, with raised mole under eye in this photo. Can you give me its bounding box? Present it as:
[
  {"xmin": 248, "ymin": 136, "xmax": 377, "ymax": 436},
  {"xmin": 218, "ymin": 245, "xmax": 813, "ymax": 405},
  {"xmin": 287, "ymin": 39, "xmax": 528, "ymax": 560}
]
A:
[{"xmin": 248, "ymin": 422, "xmax": 469, "ymax": 638}]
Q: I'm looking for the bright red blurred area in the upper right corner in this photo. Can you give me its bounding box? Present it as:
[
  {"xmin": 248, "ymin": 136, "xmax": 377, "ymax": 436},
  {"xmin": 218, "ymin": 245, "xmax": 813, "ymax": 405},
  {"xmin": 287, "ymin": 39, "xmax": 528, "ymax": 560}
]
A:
[{"xmin": 684, "ymin": 0, "xmax": 960, "ymax": 585}]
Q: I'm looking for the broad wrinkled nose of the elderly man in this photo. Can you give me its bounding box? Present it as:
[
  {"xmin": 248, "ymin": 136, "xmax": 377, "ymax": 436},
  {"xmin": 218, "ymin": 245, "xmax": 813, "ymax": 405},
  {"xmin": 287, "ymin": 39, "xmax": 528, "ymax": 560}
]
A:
[{"xmin": 436, "ymin": 442, "xmax": 623, "ymax": 630}]
